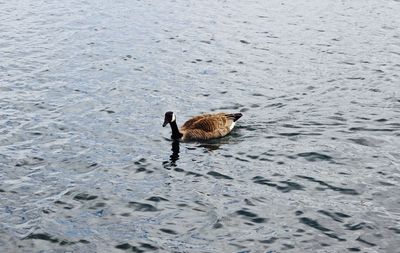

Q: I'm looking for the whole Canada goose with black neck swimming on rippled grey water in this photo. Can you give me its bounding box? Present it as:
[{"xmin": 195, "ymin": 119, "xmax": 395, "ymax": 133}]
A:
[{"xmin": 163, "ymin": 112, "xmax": 242, "ymax": 141}]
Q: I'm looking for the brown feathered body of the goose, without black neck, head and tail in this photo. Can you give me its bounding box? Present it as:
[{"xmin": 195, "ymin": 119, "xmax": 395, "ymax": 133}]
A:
[{"xmin": 181, "ymin": 113, "xmax": 234, "ymax": 140}]
